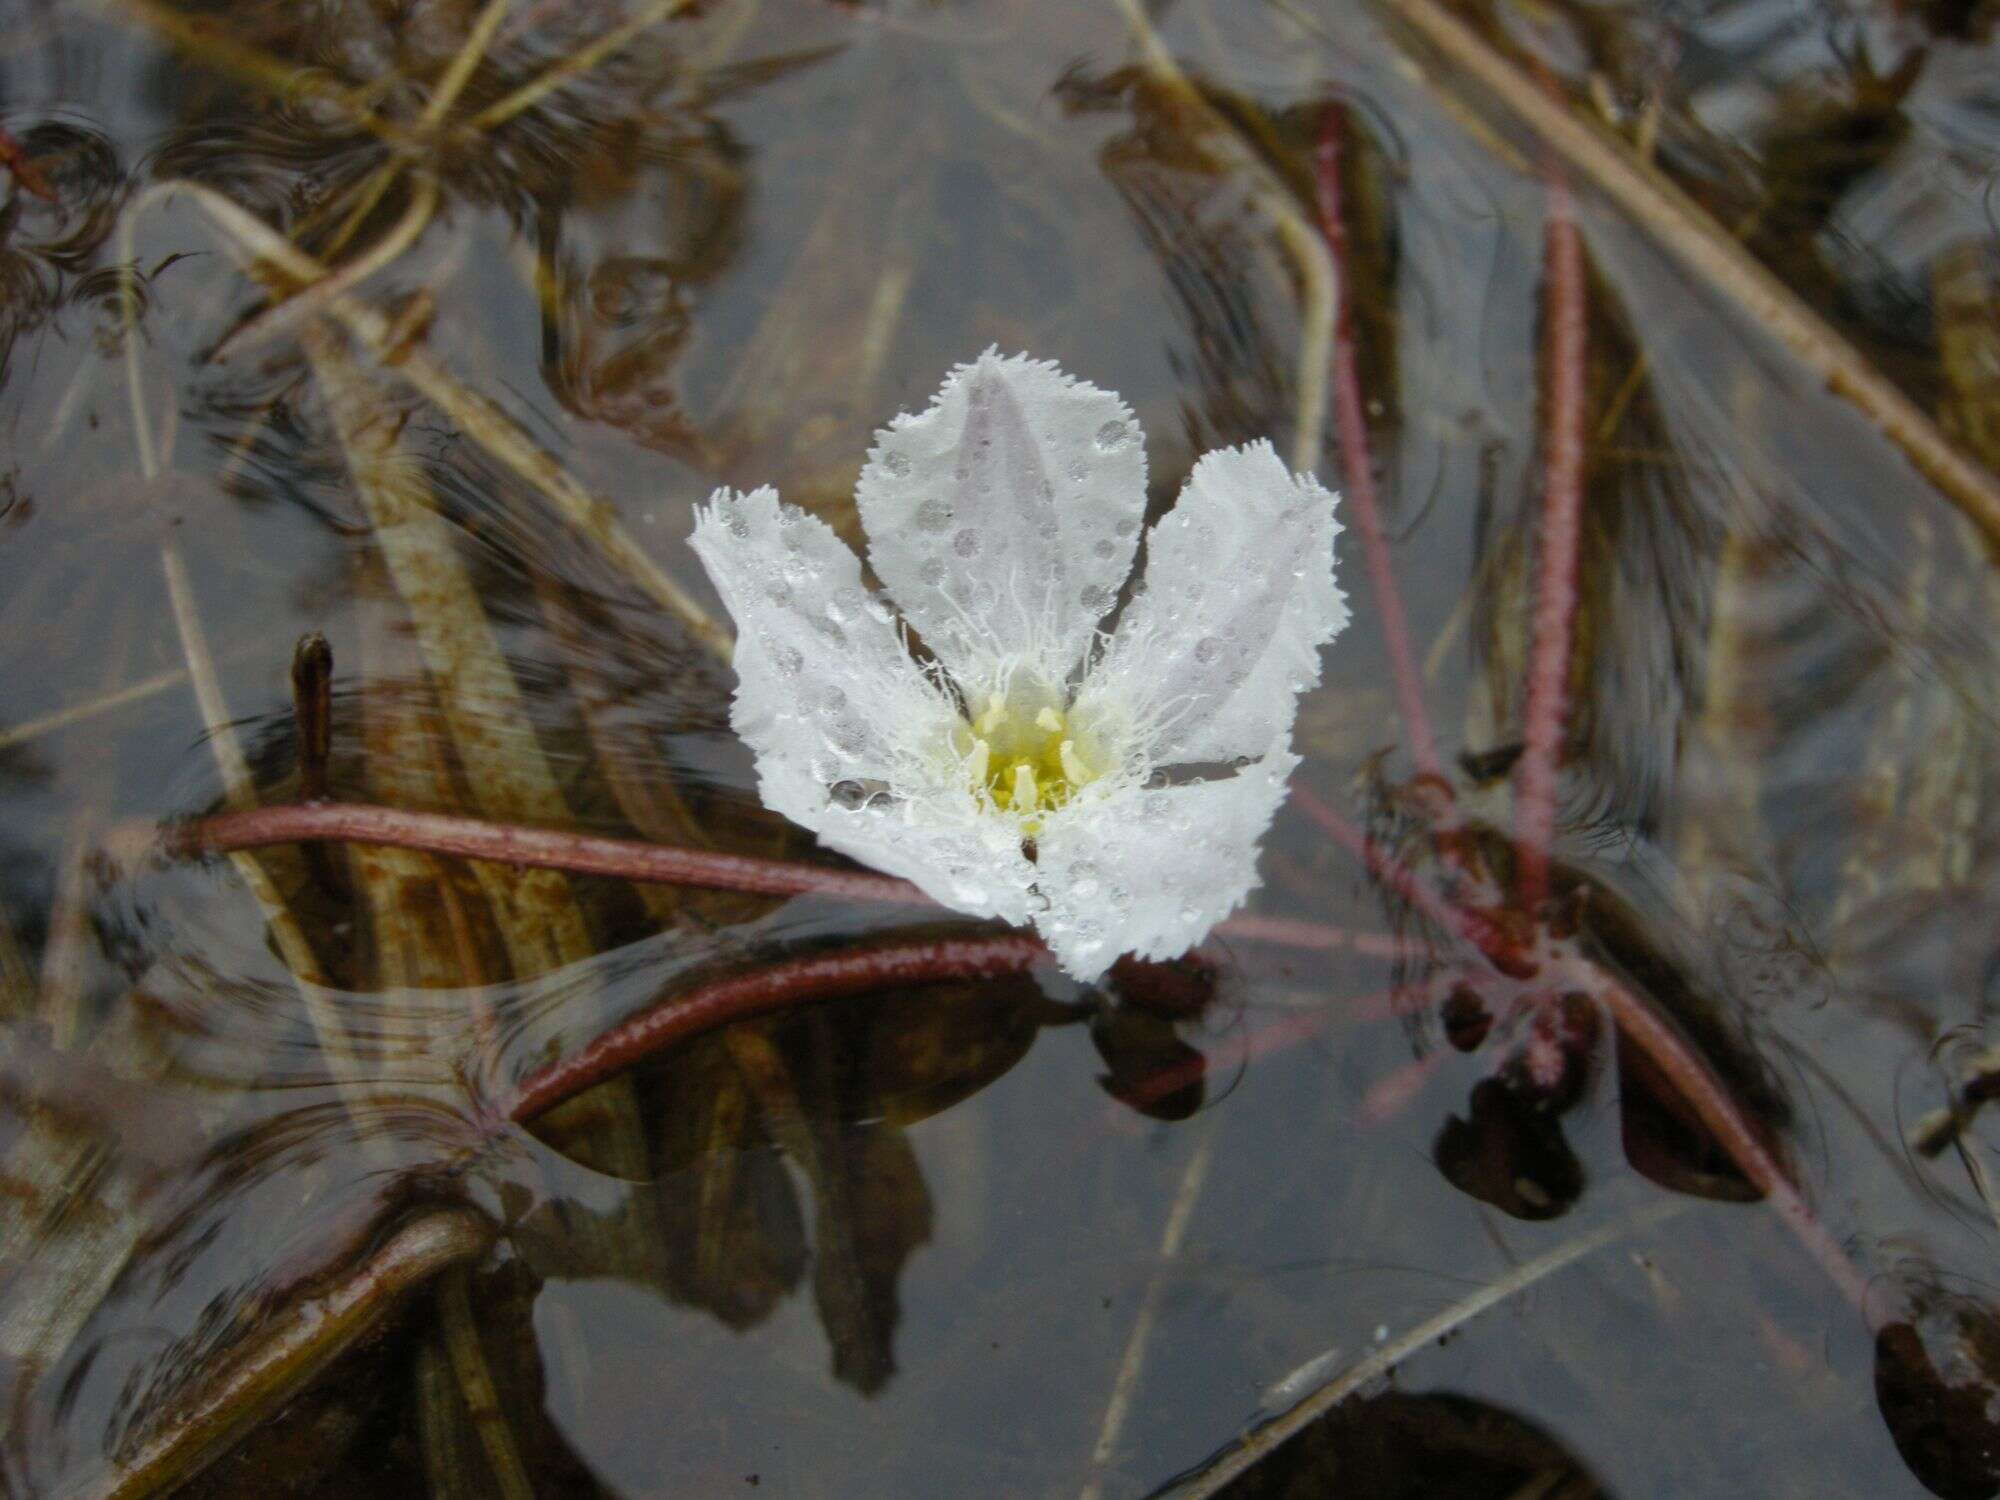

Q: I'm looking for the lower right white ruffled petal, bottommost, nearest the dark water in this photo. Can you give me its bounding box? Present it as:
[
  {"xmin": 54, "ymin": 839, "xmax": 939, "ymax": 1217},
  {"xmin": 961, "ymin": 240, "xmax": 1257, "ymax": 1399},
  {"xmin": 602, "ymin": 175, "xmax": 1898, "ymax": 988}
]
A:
[{"xmin": 1036, "ymin": 748, "xmax": 1298, "ymax": 982}]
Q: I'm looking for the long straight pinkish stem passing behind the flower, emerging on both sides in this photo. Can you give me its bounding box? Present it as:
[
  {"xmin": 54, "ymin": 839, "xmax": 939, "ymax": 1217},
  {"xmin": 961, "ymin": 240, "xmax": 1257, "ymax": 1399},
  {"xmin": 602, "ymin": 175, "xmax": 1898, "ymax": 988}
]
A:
[{"xmin": 164, "ymin": 802, "xmax": 1376, "ymax": 956}]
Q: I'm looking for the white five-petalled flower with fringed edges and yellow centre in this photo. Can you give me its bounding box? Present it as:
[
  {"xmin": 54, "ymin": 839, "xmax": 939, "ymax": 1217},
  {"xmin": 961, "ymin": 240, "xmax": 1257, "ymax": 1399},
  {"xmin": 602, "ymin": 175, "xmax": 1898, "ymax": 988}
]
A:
[{"xmin": 694, "ymin": 350, "xmax": 1348, "ymax": 980}]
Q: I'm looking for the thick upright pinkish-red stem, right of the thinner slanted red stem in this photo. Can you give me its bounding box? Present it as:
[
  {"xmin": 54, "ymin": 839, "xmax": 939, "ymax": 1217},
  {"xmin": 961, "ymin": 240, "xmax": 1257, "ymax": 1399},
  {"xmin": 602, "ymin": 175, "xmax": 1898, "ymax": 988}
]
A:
[{"xmin": 1514, "ymin": 176, "xmax": 1588, "ymax": 910}]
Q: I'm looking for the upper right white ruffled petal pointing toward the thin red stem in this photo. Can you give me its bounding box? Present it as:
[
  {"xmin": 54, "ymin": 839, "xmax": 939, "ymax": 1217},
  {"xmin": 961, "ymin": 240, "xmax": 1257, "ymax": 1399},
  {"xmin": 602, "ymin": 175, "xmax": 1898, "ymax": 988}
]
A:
[{"xmin": 1076, "ymin": 442, "xmax": 1348, "ymax": 766}]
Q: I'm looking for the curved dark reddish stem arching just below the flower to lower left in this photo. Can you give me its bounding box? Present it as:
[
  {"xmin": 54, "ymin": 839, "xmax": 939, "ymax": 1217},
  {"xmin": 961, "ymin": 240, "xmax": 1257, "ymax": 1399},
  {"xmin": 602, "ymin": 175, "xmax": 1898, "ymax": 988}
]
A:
[{"xmin": 506, "ymin": 934, "xmax": 1048, "ymax": 1124}]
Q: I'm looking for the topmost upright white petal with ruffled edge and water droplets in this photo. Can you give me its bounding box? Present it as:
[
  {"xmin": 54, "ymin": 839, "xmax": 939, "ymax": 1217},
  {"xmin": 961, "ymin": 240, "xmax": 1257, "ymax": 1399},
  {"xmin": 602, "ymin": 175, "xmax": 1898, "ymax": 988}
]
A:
[{"xmin": 854, "ymin": 350, "xmax": 1146, "ymax": 694}]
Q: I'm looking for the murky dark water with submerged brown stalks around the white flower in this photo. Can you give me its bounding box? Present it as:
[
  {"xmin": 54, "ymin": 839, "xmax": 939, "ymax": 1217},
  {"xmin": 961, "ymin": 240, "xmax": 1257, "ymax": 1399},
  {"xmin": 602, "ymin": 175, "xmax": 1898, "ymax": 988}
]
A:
[{"xmin": 0, "ymin": 0, "xmax": 2000, "ymax": 1496}]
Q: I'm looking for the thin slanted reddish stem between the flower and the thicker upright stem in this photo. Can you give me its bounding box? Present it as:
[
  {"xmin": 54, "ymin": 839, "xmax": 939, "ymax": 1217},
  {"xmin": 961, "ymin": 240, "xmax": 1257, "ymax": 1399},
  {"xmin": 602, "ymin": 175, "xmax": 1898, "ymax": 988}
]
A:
[{"xmin": 1314, "ymin": 104, "xmax": 1444, "ymax": 780}]
